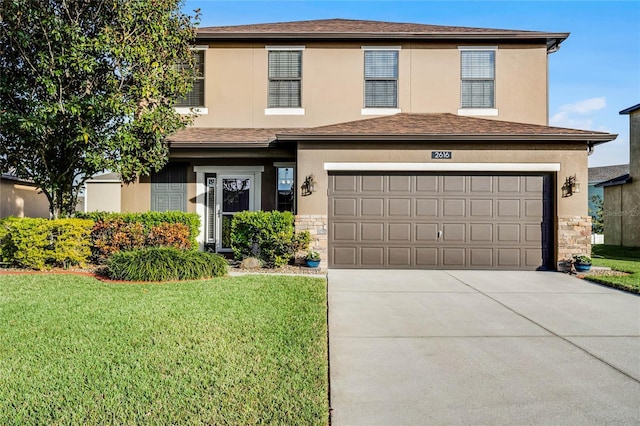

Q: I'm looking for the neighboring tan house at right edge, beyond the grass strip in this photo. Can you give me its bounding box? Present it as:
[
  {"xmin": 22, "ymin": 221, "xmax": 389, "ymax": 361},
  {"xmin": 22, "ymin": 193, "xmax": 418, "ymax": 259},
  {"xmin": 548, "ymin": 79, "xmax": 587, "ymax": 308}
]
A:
[{"xmin": 597, "ymin": 104, "xmax": 640, "ymax": 247}]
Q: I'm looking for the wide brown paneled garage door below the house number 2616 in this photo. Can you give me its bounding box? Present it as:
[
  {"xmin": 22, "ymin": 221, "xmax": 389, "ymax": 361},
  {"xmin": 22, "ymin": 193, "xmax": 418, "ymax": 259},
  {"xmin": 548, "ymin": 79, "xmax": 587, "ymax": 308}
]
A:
[{"xmin": 329, "ymin": 172, "xmax": 552, "ymax": 270}]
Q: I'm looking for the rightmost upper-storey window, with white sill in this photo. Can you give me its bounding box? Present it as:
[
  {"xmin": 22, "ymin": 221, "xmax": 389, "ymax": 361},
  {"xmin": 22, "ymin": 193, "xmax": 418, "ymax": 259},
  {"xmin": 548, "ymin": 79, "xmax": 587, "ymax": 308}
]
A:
[{"xmin": 460, "ymin": 50, "xmax": 496, "ymax": 108}]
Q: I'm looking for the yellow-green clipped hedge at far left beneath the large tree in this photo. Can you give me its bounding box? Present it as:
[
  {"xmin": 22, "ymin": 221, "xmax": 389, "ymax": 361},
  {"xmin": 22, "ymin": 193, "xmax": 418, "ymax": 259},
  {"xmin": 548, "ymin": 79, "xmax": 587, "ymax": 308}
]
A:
[{"xmin": 0, "ymin": 218, "xmax": 94, "ymax": 269}]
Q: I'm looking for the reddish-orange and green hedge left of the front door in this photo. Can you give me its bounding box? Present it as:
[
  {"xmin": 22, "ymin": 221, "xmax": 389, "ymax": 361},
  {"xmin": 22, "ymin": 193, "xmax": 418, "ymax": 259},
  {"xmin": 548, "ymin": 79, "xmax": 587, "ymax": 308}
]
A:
[{"xmin": 76, "ymin": 211, "xmax": 200, "ymax": 262}]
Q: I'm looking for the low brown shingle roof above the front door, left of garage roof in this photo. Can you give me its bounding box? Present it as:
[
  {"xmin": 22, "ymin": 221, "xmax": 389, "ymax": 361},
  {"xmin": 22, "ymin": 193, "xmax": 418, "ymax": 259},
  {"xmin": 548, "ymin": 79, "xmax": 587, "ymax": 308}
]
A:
[{"xmin": 168, "ymin": 127, "xmax": 287, "ymax": 148}]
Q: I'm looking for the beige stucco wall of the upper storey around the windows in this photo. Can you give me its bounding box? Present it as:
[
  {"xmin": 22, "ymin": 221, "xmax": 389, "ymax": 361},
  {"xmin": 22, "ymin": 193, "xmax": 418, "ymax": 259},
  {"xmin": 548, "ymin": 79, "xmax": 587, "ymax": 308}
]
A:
[{"xmin": 194, "ymin": 42, "xmax": 548, "ymax": 128}]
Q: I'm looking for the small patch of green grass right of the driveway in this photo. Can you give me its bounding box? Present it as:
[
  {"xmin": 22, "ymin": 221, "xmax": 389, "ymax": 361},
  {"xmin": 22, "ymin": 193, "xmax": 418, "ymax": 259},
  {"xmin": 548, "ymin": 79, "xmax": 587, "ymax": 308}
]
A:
[{"xmin": 585, "ymin": 245, "xmax": 640, "ymax": 293}]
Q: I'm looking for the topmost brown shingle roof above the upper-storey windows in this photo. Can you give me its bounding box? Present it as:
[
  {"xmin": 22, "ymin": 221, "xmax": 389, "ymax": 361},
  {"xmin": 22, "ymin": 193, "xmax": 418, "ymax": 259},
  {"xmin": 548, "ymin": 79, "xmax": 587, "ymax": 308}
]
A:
[{"xmin": 197, "ymin": 19, "xmax": 569, "ymax": 47}]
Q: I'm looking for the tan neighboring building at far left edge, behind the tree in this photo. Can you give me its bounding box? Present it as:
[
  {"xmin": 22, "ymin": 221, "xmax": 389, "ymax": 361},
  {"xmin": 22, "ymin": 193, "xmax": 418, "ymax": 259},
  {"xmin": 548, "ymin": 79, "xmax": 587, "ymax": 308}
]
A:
[{"xmin": 0, "ymin": 173, "xmax": 49, "ymax": 218}]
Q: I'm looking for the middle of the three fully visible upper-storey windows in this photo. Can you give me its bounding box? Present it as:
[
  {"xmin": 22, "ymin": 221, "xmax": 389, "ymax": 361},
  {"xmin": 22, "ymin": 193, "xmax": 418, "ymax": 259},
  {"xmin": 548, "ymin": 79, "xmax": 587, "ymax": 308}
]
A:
[{"xmin": 364, "ymin": 50, "xmax": 398, "ymax": 108}]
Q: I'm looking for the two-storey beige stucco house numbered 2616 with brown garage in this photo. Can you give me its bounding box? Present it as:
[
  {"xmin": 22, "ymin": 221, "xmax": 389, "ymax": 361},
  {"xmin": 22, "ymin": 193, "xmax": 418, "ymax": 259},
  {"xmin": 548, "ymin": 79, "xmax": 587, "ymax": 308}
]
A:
[{"xmin": 121, "ymin": 19, "xmax": 616, "ymax": 269}]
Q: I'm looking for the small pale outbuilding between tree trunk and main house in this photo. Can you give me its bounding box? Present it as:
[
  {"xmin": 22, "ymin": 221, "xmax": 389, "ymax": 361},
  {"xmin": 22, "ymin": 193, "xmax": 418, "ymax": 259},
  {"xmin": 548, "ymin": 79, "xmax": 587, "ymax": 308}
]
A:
[{"xmin": 83, "ymin": 173, "xmax": 122, "ymax": 213}]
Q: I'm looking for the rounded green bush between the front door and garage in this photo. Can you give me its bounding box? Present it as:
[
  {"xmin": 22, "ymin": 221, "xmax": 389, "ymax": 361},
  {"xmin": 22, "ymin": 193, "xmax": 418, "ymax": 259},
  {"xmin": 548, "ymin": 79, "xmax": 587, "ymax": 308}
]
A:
[{"xmin": 231, "ymin": 211, "xmax": 310, "ymax": 267}]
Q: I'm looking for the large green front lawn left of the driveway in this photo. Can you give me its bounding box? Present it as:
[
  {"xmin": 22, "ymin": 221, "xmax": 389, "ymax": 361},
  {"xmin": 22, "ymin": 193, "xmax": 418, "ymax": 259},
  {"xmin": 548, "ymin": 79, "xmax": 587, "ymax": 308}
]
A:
[{"xmin": 0, "ymin": 275, "xmax": 328, "ymax": 425}]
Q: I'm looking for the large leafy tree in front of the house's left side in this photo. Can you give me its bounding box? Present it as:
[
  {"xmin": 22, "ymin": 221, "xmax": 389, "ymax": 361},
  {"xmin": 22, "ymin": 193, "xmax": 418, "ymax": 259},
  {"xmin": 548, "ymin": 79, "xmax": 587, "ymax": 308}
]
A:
[{"xmin": 0, "ymin": 0, "xmax": 198, "ymax": 217}]
